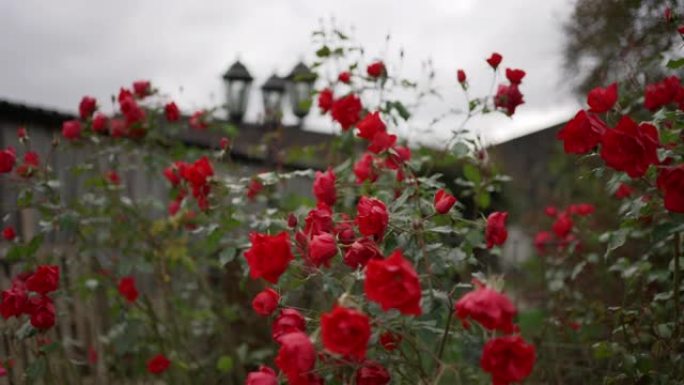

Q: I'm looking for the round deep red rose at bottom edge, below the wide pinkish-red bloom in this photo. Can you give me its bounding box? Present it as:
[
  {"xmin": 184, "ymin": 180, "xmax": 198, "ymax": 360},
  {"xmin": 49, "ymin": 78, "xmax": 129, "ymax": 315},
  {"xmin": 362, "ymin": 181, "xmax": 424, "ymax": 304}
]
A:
[{"xmin": 480, "ymin": 335, "xmax": 536, "ymax": 385}]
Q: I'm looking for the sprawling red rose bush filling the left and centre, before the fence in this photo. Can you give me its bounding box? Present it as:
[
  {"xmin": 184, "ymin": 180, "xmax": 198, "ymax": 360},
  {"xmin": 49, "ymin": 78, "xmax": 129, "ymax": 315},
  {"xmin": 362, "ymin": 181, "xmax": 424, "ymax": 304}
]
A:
[{"xmin": 0, "ymin": 24, "xmax": 544, "ymax": 385}]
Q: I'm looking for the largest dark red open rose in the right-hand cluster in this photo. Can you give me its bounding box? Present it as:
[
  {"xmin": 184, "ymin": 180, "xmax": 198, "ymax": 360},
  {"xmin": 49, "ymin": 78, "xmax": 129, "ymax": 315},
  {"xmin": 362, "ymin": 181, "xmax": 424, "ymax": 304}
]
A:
[{"xmin": 601, "ymin": 116, "xmax": 660, "ymax": 178}]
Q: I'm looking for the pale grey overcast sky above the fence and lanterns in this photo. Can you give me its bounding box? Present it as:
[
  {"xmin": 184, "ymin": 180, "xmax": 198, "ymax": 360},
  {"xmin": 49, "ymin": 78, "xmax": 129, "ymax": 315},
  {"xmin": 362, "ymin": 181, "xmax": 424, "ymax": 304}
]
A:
[{"xmin": 0, "ymin": 0, "xmax": 579, "ymax": 146}]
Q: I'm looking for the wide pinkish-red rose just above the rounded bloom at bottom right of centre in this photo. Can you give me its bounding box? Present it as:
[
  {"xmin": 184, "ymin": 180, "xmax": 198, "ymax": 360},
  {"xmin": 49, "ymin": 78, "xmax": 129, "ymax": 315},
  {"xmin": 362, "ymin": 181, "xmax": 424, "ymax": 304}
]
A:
[{"xmin": 454, "ymin": 286, "xmax": 517, "ymax": 333}]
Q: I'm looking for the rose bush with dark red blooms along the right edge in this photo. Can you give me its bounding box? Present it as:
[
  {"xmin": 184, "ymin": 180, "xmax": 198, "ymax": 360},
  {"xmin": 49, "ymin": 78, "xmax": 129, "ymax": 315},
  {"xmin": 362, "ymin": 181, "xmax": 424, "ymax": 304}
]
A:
[{"xmin": 521, "ymin": 9, "xmax": 684, "ymax": 384}]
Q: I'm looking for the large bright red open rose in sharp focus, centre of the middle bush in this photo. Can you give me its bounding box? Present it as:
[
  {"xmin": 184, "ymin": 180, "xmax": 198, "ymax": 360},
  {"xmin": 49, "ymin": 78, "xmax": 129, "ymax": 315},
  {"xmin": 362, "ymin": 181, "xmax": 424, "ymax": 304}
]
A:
[{"xmin": 363, "ymin": 250, "xmax": 422, "ymax": 315}]
